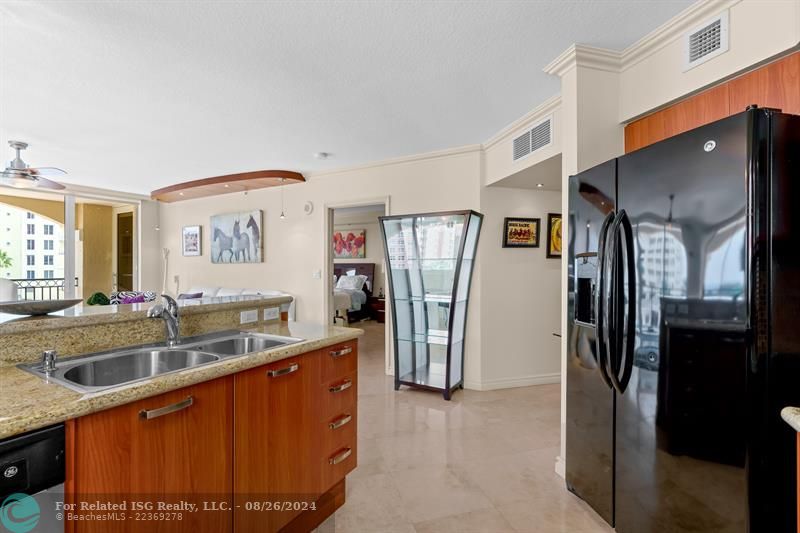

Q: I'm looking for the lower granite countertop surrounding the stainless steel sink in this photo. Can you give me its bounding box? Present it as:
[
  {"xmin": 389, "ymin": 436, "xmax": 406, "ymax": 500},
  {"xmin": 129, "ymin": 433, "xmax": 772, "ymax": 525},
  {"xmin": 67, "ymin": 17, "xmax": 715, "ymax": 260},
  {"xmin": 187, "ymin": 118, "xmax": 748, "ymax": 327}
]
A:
[{"xmin": 0, "ymin": 322, "xmax": 363, "ymax": 439}]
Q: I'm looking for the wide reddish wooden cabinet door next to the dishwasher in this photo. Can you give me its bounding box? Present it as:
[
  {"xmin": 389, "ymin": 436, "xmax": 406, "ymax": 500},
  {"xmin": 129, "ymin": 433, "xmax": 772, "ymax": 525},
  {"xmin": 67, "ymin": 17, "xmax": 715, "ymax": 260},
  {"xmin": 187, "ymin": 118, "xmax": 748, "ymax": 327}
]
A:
[{"xmin": 66, "ymin": 376, "xmax": 233, "ymax": 533}]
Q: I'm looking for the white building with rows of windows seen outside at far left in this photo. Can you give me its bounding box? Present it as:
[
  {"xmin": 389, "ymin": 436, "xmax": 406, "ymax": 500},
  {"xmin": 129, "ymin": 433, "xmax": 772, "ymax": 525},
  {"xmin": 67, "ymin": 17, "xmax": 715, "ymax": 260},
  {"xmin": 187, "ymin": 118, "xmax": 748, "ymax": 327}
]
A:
[{"xmin": 0, "ymin": 204, "xmax": 64, "ymax": 279}]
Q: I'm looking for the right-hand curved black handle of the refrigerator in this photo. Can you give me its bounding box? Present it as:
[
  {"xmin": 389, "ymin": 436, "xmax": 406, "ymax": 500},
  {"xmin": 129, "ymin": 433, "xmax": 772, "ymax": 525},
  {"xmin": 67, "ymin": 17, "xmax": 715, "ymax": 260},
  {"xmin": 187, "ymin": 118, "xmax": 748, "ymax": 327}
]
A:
[{"xmin": 609, "ymin": 209, "xmax": 636, "ymax": 394}]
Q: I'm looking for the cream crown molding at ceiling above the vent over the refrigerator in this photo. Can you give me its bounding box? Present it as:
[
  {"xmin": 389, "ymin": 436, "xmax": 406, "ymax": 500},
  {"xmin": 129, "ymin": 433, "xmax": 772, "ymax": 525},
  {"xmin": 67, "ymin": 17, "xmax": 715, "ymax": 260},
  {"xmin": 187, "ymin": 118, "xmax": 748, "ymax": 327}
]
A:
[{"xmin": 622, "ymin": 0, "xmax": 742, "ymax": 70}]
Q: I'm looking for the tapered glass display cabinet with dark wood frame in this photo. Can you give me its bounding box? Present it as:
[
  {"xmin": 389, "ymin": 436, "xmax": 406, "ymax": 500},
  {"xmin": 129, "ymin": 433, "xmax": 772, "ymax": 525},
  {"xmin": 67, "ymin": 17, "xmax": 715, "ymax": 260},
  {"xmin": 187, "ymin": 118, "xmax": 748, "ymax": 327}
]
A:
[{"xmin": 380, "ymin": 211, "xmax": 483, "ymax": 400}]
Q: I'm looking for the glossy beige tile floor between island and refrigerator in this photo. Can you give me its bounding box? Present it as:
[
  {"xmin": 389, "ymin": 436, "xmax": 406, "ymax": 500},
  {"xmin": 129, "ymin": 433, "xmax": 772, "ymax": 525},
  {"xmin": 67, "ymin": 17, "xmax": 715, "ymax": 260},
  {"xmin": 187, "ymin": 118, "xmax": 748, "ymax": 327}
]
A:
[{"xmin": 318, "ymin": 322, "xmax": 612, "ymax": 533}]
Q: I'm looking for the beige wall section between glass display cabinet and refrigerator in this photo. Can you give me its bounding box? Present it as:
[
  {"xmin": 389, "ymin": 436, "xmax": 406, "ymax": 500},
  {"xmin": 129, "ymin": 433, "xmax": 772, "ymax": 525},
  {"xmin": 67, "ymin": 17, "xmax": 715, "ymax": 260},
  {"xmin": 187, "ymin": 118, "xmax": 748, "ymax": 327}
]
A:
[{"xmin": 470, "ymin": 187, "xmax": 561, "ymax": 390}]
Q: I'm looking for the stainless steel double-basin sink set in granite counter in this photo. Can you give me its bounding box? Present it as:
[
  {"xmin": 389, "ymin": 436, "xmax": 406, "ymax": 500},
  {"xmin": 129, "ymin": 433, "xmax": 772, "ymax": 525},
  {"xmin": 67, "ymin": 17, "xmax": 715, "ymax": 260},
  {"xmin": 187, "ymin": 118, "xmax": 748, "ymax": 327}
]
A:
[{"xmin": 19, "ymin": 331, "xmax": 303, "ymax": 392}]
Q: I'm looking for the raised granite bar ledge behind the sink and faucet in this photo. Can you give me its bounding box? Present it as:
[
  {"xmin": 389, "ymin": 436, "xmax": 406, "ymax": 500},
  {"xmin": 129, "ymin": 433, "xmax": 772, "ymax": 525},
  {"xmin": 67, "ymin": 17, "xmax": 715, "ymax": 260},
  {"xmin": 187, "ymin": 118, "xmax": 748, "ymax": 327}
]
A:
[{"xmin": 0, "ymin": 295, "xmax": 292, "ymax": 335}]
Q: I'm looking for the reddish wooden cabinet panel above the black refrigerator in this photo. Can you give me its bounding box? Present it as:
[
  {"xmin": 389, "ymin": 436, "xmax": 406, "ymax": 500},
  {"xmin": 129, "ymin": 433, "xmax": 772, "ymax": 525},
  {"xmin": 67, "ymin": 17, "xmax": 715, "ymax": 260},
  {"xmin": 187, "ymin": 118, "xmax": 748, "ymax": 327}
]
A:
[{"xmin": 625, "ymin": 52, "xmax": 800, "ymax": 153}]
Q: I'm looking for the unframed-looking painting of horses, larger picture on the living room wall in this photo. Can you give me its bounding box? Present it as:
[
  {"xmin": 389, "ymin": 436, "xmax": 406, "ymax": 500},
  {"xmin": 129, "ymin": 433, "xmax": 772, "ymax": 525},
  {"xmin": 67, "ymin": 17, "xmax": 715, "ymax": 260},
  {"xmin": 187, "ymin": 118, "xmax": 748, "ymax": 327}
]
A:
[{"xmin": 211, "ymin": 209, "xmax": 264, "ymax": 263}]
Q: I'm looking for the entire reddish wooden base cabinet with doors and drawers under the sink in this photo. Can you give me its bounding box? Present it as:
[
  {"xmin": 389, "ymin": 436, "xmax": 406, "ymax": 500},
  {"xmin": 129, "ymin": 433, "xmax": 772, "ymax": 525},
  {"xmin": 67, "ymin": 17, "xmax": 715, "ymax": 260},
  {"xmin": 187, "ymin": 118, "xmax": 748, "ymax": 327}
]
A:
[{"xmin": 65, "ymin": 340, "xmax": 358, "ymax": 533}]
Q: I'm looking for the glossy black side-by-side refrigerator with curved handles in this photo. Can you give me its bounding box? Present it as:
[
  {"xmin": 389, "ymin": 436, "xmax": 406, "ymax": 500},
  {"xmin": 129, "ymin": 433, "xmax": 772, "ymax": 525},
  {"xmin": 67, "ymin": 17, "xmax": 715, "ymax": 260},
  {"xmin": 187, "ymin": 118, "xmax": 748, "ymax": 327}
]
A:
[{"xmin": 566, "ymin": 107, "xmax": 800, "ymax": 533}]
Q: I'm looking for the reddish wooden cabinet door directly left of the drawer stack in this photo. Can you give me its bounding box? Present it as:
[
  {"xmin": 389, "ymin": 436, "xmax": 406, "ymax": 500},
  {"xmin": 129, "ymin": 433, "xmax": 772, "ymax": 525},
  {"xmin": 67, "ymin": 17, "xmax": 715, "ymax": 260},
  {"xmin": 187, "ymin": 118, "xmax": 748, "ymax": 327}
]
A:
[{"xmin": 234, "ymin": 351, "xmax": 323, "ymax": 533}]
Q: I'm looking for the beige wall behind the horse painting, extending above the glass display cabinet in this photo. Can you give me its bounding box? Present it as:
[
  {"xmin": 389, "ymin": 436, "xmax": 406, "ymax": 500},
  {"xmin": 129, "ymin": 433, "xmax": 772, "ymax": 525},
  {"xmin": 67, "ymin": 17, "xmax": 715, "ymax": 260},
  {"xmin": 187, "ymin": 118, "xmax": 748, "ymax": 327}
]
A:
[{"xmin": 159, "ymin": 147, "xmax": 481, "ymax": 382}]
